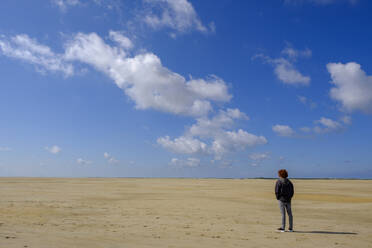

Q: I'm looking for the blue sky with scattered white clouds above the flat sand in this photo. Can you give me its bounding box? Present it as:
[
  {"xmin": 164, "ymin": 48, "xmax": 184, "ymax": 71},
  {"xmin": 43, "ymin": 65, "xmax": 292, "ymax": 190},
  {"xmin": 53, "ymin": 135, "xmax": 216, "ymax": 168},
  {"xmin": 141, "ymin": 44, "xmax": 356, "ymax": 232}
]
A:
[{"xmin": 0, "ymin": 0, "xmax": 372, "ymax": 178}]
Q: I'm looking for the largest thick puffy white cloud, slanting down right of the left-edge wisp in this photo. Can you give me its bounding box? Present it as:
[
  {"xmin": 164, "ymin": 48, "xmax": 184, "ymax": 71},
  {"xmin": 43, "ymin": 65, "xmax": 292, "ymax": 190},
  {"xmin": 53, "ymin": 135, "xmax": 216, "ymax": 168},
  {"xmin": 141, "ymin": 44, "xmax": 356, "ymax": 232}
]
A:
[{"xmin": 66, "ymin": 33, "xmax": 231, "ymax": 116}]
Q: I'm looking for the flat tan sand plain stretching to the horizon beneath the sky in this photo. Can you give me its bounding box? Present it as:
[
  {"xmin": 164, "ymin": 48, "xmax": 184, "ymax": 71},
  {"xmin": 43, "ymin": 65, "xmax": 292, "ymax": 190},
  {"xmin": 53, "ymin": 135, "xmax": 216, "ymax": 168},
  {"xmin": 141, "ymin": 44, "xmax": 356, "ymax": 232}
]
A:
[{"xmin": 0, "ymin": 178, "xmax": 372, "ymax": 248}]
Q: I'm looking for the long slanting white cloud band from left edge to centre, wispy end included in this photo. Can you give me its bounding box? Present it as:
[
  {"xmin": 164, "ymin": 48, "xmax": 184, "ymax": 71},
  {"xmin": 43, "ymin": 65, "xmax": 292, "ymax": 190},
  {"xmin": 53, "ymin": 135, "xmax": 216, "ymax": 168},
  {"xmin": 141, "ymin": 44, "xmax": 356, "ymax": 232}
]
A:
[{"xmin": 0, "ymin": 31, "xmax": 232, "ymax": 117}]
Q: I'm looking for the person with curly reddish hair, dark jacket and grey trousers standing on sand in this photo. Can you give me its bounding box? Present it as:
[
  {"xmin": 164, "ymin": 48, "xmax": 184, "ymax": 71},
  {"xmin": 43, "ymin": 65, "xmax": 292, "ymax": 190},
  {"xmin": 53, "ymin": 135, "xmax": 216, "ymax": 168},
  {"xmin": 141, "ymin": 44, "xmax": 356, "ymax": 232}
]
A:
[{"xmin": 275, "ymin": 169, "xmax": 294, "ymax": 232}]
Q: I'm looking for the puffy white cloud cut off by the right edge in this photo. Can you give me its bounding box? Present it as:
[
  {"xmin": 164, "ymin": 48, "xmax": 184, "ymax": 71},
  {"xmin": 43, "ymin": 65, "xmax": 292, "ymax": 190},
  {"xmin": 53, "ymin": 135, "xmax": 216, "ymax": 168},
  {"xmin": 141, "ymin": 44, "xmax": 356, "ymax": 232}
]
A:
[{"xmin": 327, "ymin": 62, "xmax": 372, "ymax": 114}]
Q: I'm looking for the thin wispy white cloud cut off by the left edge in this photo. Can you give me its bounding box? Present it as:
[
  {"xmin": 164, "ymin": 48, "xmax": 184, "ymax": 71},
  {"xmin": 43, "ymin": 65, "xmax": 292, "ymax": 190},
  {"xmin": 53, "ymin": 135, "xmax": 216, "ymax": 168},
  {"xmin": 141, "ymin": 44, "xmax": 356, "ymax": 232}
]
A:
[{"xmin": 0, "ymin": 34, "xmax": 74, "ymax": 76}]
